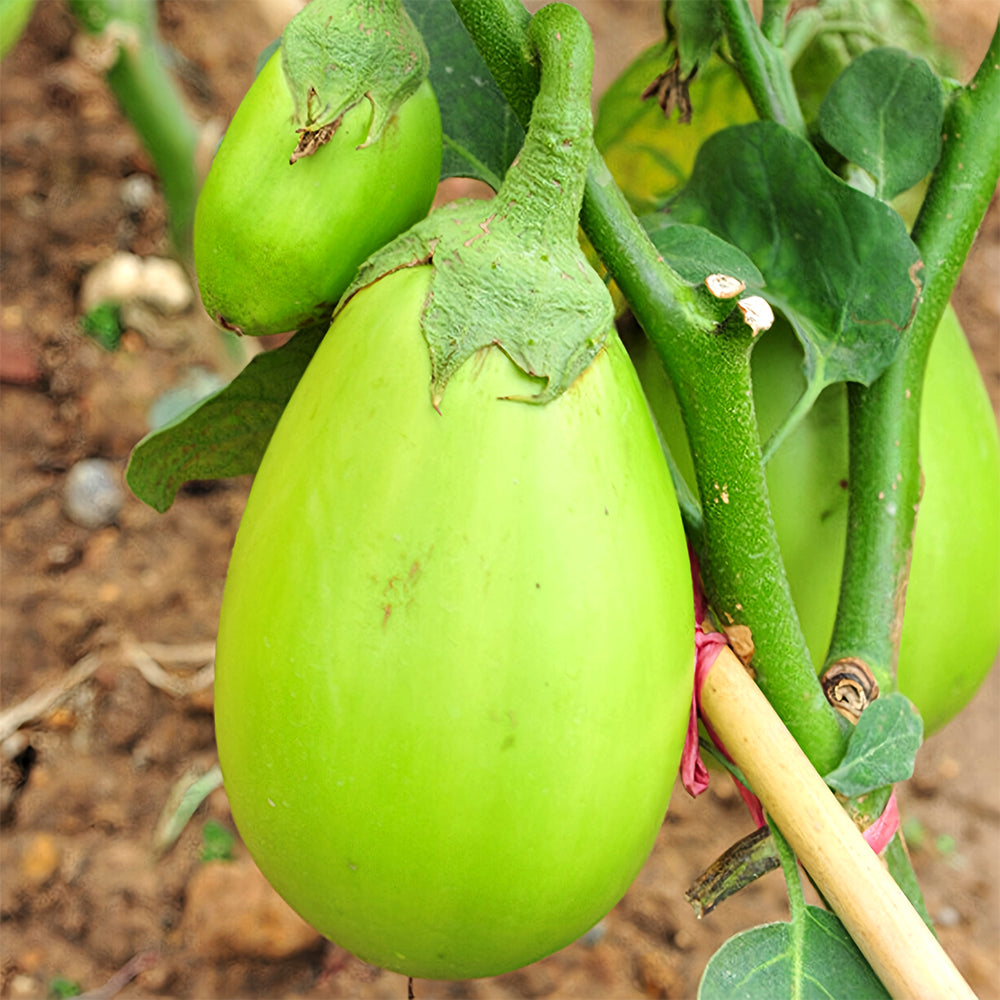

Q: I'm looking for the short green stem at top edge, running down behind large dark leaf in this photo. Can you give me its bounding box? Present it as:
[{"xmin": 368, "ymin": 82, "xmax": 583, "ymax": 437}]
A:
[{"xmin": 719, "ymin": 0, "xmax": 806, "ymax": 138}]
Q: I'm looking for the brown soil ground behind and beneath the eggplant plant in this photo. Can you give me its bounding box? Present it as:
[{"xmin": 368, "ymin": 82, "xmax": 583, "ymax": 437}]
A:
[{"xmin": 0, "ymin": 0, "xmax": 1000, "ymax": 998}]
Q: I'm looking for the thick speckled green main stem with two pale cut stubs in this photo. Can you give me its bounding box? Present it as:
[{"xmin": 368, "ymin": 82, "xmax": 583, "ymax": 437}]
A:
[{"xmin": 453, "ymin": 0, "xmax": 845, "ymax": 773}]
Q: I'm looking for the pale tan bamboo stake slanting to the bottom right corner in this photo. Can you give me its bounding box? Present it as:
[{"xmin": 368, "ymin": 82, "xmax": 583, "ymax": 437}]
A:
[{"xmin": 701, "ymin": 647, "xmax": 975, "ymax": 1000}]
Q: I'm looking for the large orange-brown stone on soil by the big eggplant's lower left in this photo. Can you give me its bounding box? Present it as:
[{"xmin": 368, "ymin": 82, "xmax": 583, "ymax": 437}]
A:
[{"xmin": 183, "ymin": 857, "xmax": 323, "ymax": 961}]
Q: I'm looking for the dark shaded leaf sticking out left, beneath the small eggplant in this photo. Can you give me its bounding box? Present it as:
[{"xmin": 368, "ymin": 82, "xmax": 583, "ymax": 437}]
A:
[{"xmin": 125, "ymin": 326, "xmax": 326, "ymax": 514}]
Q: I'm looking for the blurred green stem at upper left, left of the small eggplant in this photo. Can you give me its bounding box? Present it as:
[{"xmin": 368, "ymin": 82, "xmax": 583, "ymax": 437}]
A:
[{"xmin": 70, "ymin": 0, "xmax": 199, "ymax": 259}]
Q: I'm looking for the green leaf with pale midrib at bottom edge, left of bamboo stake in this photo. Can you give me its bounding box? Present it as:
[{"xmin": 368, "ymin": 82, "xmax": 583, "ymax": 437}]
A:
[{"xmin": 698, "ymin": 906, "xmax": 889, "ymax": 1000}]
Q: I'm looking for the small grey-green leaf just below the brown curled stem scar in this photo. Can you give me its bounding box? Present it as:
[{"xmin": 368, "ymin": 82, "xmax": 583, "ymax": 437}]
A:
[{"xmin": 825, "ymin": 692, "xmax": 924, "ymax": 798}]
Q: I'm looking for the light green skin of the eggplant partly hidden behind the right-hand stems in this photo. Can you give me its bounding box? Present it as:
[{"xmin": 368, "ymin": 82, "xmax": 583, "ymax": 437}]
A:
[{"xmin": 633, "ymin": 307, "xmax": 1000, "ymax": 734}]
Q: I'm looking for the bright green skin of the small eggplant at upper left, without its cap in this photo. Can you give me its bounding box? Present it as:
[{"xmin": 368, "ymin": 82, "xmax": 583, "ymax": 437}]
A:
[{"xmin": 194, "ymin": 49, "xmax": 442, "ymax": 335}]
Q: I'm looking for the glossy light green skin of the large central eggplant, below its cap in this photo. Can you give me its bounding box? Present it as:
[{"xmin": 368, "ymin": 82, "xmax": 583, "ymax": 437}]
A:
[{"xmin": 215, "ymin": 267, "xmax": 693, "ymax": 979}]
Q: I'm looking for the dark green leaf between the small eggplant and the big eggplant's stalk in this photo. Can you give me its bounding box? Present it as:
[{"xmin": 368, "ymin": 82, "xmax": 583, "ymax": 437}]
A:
[{"xmin": 403, "ymin": 0, "xmax": 524, "ymax": 191}]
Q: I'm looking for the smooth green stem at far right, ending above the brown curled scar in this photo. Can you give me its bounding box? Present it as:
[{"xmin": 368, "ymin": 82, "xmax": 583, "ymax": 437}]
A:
[{"xmin": 827, "ymin": 27, "xmax": 1000, "ymax": 690}]
